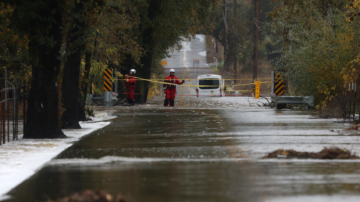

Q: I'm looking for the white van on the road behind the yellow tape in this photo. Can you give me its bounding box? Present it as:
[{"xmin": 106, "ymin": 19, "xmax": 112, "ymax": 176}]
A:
[{"xmin": 196, "ymin": 74, "xmax": 225, "ymax": 97}]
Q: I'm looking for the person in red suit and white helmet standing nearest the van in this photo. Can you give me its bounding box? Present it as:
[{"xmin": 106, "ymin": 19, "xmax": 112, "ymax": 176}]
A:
[{"xmin": 164, "ymin": 69, "xmax": 185, "ymax": 107}]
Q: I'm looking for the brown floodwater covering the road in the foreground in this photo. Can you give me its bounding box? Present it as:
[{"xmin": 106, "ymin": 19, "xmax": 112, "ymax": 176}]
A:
[{"xmin": 6, "ymin": 104, "xmax": 360, "ymax": 202}]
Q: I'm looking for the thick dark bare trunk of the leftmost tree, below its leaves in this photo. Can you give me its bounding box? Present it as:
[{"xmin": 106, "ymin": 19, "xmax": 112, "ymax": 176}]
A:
[{"xmin": 24, "ymin": 36, "xmax": 66, "ymax": 138}]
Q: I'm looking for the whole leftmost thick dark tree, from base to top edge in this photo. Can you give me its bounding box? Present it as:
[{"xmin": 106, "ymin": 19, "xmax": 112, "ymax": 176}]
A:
[{"xmin": 10, "ymin": 0, "xmax": 66, "ymax": 138}]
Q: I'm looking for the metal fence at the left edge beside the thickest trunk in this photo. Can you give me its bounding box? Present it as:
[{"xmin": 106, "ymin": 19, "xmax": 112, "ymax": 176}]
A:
[{"xmin": 0, "ymin": 82, "xmax": 28, "ymax": 145}]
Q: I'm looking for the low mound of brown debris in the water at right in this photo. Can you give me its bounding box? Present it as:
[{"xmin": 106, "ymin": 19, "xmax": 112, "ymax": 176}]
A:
[{"xmin": 262, "ymin": 147, "xmax": 360, "ymax": 159}]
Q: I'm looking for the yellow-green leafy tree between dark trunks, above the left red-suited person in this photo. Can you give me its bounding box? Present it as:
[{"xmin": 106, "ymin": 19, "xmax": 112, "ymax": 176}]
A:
[{"xmin": 84, "ymin": 0, "xmax": 143, "ymax": 98}]
